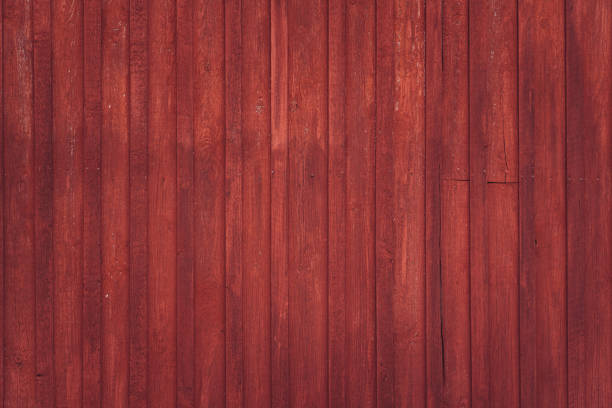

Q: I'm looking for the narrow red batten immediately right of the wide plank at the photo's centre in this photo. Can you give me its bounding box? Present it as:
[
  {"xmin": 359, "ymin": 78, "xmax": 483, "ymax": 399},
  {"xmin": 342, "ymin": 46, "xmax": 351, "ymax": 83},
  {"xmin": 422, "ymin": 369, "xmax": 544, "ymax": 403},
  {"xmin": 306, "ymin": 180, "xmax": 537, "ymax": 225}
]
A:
[{"xmin": 328, "ymin": 0, "xmax": 347, "ymax": 406}]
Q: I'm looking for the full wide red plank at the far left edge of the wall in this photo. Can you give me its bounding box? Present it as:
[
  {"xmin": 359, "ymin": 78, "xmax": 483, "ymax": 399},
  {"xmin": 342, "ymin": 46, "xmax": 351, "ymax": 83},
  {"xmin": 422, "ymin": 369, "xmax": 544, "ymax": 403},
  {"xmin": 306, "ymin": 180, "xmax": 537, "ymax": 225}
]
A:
[{"xmin": 2, "ymin": 1, "xmax": 36, "ymax": 407}]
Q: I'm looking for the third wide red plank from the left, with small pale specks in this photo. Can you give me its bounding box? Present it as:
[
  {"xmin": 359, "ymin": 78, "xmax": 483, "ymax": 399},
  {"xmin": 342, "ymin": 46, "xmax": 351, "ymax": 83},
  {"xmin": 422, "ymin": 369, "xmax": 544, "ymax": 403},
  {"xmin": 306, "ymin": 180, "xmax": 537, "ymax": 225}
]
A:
[{"xmin": 101, "ymin": 0, "xmax": 129, "ymax": 407}]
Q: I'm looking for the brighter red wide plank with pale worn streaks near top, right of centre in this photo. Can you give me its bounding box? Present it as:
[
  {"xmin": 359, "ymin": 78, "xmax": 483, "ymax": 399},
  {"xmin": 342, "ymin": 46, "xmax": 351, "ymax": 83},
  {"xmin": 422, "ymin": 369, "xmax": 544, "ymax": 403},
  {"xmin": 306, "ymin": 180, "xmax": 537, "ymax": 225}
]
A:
[{"xmin": 393, "ymin": 0, "xmax": 426, "ymax": 407}]
